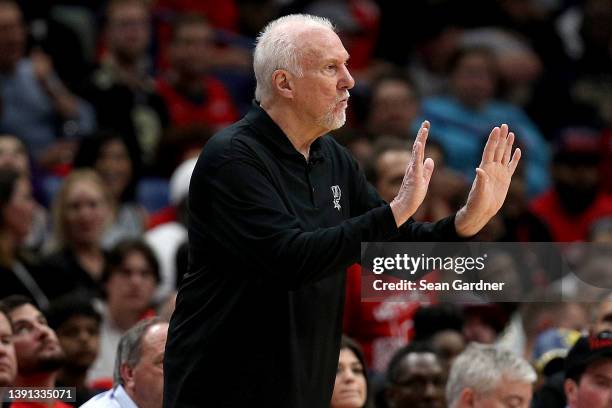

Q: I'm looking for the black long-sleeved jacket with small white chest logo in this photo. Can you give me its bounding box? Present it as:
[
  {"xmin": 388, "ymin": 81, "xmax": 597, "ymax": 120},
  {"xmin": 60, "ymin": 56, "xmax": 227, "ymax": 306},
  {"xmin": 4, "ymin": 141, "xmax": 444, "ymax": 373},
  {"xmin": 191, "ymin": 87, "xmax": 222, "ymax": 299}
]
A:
[{"xmin": 164, "ymin": 107, "xmax": 464, "ymax": 408}]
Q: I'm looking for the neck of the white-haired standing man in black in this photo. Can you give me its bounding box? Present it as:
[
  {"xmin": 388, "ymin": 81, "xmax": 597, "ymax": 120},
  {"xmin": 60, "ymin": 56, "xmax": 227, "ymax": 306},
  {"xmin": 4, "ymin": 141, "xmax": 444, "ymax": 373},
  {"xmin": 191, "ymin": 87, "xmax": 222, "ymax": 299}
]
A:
[{"xmin": 261, "ymin": 103, "xmax": 328, "ymax": 160}]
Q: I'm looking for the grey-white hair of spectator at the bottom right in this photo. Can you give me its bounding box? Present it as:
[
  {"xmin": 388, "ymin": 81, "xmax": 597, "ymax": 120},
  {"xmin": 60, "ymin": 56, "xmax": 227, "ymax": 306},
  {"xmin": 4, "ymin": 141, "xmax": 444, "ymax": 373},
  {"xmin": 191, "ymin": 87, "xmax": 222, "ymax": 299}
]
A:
[{"xmin": 446, "ymin": 343, "xmax": 537, "ymax": 408}]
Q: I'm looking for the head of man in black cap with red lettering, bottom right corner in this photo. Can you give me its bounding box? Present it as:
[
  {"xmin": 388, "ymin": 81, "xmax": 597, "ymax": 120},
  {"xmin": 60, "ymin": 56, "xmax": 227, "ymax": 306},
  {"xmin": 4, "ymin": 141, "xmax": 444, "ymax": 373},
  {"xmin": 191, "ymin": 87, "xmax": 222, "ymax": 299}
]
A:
[{"xmin": 564, "ymin": 331, "xmax": 612, "ymax": 408}]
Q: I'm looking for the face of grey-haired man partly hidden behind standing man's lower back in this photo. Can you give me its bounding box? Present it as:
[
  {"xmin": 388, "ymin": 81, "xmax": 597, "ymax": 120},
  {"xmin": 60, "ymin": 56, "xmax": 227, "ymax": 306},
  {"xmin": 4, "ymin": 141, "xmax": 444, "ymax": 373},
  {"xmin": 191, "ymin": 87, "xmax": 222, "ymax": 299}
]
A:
[{"xmin": 121, "ymin": 323, "xmax": 168, "ymax": 408}]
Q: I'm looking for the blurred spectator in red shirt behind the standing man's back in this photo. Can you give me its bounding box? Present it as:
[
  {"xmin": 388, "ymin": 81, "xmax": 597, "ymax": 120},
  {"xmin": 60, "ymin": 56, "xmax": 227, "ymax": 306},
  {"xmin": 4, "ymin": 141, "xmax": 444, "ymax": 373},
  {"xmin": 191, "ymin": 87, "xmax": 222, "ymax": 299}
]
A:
[{"xmin": 157, "ymin": 14, "xmax": 238, "ymax": 129}]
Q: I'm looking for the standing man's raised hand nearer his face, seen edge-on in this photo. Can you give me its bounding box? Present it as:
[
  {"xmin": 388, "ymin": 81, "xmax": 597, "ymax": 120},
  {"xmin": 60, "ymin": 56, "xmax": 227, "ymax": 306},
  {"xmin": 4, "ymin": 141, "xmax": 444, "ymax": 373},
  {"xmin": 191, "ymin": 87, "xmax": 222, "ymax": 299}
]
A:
[{"xmin": 391, "ymin": 121, "xmax": 434, "ymax": 227}]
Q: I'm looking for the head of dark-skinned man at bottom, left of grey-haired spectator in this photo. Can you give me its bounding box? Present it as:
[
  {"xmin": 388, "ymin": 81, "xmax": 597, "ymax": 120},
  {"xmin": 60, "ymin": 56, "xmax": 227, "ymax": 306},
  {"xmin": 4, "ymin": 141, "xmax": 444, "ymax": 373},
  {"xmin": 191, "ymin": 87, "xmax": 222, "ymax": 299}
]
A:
[{"xmin": 385, "ymin": 343, "xmax": 446, "ymax": 408}]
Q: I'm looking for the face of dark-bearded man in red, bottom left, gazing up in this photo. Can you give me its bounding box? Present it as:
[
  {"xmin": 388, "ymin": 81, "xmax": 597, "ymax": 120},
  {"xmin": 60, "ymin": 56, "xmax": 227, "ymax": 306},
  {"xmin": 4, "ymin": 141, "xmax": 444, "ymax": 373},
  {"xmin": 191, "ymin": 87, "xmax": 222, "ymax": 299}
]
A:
[{"xmin": 9, "ymin": 304, "xmax": 64, "ymax": 376}]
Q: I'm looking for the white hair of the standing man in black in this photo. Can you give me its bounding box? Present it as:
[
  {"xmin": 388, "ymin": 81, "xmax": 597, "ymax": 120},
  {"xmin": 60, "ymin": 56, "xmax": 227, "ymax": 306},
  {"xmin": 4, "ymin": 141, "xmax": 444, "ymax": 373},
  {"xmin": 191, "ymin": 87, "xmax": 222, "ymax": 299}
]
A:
[{"xmin": 253, "ymin": 14, "xmax": 335, "ymax": 102}]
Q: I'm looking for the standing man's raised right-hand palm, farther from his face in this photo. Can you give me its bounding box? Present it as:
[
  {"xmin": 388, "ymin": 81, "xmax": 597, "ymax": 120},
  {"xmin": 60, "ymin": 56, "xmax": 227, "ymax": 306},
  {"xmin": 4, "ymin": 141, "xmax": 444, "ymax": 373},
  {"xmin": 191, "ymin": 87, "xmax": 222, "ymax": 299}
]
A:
[{"xmin": 455, "ymin": 124, "xmax": 521, "ymax": 237}]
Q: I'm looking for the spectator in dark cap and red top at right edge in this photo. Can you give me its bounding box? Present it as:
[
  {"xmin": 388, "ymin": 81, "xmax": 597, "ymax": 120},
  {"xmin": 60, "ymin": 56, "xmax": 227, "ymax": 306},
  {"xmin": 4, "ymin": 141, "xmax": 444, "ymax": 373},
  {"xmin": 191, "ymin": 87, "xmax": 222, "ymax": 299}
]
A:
[{"xmin": 531, "ymin": 128, "xmax": 612, "ymax": 242}]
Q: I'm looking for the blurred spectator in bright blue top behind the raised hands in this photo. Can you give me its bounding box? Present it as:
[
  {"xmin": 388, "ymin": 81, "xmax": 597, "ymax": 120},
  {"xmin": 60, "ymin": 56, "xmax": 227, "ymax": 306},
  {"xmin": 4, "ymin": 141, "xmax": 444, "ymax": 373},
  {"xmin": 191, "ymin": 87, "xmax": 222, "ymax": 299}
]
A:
[{"xmin": 422, "ymin": 47, "xmax": 549, "ymax": 197}]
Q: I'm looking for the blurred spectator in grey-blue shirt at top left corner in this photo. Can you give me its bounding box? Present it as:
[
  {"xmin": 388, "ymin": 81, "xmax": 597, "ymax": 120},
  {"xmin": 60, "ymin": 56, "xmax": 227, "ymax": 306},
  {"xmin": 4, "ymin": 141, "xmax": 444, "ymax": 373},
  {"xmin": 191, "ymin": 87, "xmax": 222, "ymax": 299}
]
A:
[{"xmin": 0, "ymin": 0, "xmax": 95, "ymax": 168}]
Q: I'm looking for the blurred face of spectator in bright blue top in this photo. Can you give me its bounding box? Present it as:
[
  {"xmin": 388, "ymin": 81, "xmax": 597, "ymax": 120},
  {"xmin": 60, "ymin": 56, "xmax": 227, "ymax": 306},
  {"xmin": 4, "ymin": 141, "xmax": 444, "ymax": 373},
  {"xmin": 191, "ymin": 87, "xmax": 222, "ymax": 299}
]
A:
[{"xmin": 450, "ymin": 52, "xmax": 496, "ymax": 109}]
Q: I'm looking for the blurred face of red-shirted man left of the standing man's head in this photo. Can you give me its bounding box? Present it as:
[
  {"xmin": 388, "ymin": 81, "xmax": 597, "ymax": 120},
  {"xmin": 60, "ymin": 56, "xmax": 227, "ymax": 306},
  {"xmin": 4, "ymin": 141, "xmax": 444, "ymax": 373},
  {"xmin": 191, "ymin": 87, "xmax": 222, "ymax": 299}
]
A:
[{"xmin": 170, "ymin": 21, "xmax": 214, "ymax": 78}]
